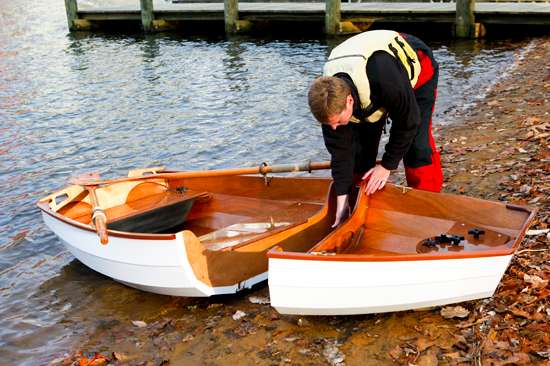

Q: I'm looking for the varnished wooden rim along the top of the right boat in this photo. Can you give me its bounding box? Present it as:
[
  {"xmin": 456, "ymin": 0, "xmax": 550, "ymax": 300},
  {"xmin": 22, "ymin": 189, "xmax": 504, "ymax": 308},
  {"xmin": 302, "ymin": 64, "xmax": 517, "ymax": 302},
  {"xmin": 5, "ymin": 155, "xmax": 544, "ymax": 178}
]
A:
[{"xmin": 267, "ymin": 184, "xmax": 538, "ymax": 262}]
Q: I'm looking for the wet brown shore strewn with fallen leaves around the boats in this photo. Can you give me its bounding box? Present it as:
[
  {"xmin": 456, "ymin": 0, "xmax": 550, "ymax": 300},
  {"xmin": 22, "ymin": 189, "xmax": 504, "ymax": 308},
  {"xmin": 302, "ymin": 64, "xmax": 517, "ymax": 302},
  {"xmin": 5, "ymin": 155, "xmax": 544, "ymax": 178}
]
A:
[{"xmin": 56, "ymin": 38, "xmax": 550, "ymax": 365}]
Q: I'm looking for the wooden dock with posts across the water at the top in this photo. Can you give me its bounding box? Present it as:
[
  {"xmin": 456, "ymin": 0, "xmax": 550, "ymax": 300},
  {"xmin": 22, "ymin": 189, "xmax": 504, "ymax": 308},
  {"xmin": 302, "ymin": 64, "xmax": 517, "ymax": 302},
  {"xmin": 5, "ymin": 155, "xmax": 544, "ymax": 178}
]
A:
[{"xmin": 65, "ymin": 0, "xmax": 550, "ymax": 37}]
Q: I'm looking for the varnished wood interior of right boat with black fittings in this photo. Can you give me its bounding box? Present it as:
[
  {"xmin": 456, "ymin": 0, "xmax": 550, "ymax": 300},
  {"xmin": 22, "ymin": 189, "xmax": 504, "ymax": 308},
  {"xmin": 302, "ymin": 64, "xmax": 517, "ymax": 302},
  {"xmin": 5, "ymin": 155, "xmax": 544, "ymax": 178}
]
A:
[{"xmin": 304, "ymin": 185, "xmax": 534, "ymax": 260}]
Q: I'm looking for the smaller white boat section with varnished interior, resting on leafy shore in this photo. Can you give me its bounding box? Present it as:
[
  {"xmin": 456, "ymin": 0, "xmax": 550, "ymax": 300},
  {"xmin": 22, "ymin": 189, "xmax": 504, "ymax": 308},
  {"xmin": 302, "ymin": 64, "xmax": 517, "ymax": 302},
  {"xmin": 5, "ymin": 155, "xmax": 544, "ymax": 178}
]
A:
[{"xmin": 268, "ymin": 184, "xmax": 534, "ymax": 315}]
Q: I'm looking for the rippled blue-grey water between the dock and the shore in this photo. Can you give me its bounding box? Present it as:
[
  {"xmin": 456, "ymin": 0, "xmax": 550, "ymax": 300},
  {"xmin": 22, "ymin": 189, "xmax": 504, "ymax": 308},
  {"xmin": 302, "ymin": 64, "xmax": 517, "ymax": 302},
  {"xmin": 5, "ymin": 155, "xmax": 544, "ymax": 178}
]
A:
[{"xmin": 0, "ymin": 0, "xmax": 528, "ymax": 365}]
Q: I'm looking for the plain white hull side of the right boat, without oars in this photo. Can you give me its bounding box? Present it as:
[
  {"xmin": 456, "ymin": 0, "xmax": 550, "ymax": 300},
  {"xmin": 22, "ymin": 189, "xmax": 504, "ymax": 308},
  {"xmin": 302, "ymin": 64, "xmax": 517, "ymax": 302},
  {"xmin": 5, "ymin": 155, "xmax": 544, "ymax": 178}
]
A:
[{"xmin": 268, "ymin": 255, "xmax": 512, "ymax": 315}]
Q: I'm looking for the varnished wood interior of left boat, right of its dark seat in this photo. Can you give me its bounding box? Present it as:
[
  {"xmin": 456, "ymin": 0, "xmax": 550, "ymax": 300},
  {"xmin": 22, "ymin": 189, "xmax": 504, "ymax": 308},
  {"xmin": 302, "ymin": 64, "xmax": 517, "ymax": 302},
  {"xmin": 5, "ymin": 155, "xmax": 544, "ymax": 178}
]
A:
[{"xmin": 173, "ymin": 176, "xmax": 331, "ymax": 250}]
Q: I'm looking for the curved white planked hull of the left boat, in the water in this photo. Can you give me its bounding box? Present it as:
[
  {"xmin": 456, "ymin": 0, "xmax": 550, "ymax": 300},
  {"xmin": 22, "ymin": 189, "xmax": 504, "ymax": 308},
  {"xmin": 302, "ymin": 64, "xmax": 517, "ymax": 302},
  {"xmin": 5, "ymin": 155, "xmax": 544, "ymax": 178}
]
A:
[{"xmin": 42, "ymin": 212, "xmax": 267, "ymax": 297}]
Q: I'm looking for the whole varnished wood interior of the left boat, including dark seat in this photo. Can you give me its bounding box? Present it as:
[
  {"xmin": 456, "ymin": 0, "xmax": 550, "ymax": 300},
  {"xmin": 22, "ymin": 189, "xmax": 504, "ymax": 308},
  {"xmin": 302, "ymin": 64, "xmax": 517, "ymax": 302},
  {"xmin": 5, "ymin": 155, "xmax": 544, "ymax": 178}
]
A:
[{"xmin": 39, "ymin": 175, "xmax": 331, "ymax": 250}]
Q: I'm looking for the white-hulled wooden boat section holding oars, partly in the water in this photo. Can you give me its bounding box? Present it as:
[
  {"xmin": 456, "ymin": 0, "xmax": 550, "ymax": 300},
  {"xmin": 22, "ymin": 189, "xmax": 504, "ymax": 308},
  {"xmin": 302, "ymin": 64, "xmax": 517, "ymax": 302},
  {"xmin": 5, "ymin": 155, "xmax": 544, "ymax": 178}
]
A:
[{"xmin": 38, "ymin": 163, "xmax": 334, "ymax": 296}]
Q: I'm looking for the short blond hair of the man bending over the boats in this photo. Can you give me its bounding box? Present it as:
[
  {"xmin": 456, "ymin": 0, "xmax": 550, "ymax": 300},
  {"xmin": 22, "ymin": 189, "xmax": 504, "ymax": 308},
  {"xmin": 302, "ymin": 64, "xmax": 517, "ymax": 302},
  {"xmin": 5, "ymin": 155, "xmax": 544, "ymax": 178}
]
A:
[{"xmin": 307, "ymin": 76, "xmax": 351, "ymax": 123}]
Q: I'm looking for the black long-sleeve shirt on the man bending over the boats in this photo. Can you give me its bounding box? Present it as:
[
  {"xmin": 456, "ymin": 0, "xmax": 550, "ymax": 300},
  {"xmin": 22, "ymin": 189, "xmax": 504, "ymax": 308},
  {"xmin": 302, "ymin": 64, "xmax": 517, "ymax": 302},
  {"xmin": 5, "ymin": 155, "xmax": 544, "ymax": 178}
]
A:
[{"xmin": 322, "ymin": 51, "xmax": 420, "ymax": 195}]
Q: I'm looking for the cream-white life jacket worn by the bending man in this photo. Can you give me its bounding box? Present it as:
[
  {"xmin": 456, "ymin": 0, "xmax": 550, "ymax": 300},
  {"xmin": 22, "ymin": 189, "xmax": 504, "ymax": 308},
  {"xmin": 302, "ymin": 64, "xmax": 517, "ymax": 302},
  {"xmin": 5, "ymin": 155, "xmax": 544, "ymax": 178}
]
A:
[{"xmin": 323, "ymin": 30, "xmax": 420, "ymax": 122}]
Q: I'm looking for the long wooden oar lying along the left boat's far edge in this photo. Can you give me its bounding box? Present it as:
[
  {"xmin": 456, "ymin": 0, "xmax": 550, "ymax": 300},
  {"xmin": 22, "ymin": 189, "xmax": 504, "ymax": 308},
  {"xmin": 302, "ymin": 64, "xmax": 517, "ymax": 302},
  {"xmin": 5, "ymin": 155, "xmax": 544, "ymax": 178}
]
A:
[{"xmin": 71, "ymin": 161, "xmax": 330, "ymax": 187}]
